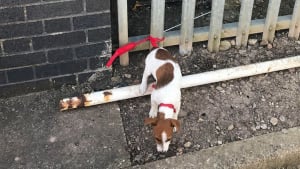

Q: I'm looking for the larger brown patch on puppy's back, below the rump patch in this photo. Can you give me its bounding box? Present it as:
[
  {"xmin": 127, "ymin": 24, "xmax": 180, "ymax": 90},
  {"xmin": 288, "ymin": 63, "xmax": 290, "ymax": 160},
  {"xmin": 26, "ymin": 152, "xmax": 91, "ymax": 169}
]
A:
[{"xmin": 156, "ymin": 63, "xmax": 174, "ymax": 89}]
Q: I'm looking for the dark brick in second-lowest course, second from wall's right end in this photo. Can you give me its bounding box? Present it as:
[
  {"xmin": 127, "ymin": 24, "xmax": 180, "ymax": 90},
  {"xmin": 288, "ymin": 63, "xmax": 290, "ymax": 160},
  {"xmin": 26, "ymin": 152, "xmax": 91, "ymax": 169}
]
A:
[{"xmin": 60, "ymin": 60, "xmax": 87, "ymax": 74}]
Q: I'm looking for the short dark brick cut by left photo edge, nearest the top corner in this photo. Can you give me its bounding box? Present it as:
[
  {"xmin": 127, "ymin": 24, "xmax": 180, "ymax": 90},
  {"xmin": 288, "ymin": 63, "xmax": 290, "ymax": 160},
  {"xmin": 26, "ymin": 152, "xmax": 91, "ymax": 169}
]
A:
[{"xmin": 0, "ymin": 7, "xmax": 25, "ymax": 23}]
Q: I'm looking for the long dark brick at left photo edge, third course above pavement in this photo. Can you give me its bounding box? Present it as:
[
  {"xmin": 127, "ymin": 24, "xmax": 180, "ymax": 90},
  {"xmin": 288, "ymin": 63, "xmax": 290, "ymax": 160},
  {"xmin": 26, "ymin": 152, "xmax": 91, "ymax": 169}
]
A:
[{"xmin": 0, "ymin": 52, "xmax": 46, "ymax": 69}]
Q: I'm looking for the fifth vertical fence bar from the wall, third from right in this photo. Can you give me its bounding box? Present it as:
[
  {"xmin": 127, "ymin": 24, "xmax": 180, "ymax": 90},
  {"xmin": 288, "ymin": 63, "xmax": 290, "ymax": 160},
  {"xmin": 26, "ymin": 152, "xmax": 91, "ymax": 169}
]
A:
[{"xmin": 236, "ymin": 0, "xmax": 254, "ymax": 47}]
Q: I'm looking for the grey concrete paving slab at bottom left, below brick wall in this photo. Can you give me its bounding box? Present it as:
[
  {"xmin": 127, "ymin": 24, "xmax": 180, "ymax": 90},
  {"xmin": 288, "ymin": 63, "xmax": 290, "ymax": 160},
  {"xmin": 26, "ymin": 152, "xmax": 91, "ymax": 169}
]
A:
[{"xmin": 0, "ymin": 91, "xmax": 130, "ymax": 169}]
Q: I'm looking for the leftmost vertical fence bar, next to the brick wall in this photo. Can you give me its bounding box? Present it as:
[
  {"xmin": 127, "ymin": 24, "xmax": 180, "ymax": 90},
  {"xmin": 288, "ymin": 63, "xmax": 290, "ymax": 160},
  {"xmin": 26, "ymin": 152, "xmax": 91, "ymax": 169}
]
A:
[{"xmin": 117, "ymin": 0, "xmax": 129, "ymax": 66}]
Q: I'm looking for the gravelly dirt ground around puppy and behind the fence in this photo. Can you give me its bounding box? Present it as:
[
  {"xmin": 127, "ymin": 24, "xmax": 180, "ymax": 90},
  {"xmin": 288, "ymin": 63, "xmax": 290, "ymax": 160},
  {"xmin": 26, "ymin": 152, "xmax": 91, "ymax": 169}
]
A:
[{"xmin": 107, "ymin": 0, "xmax": 300, "ymax": 164}]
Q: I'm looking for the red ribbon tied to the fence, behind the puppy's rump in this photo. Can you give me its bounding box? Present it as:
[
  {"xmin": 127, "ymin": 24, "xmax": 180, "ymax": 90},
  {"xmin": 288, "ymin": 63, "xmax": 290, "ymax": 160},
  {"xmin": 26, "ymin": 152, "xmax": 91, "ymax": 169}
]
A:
[{"xmin": 106, "ymin": 35, "xmax": 165, "ymax": 67}]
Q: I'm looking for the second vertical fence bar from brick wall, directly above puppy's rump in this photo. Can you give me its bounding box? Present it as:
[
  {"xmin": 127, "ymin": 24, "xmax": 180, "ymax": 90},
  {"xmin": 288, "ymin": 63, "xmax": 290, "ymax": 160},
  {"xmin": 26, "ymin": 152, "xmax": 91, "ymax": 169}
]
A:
[{"xmin": 150, "ymin": 0, "xmax": 165, "ymax": 48}]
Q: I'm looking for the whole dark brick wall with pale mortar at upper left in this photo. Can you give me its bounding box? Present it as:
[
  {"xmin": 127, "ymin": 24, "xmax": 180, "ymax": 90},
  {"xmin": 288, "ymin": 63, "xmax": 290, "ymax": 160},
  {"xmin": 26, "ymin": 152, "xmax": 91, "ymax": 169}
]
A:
[{"xmin": 0, "ymin": 0, "xmax": 111, "ymax": 96}]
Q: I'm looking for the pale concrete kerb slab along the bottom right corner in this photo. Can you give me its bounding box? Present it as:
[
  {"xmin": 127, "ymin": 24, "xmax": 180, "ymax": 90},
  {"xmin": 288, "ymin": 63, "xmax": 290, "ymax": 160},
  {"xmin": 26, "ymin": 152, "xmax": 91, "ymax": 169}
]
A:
[{"xmin": 132, "ymin": 127, "xmax": 300, "ymax": 169}]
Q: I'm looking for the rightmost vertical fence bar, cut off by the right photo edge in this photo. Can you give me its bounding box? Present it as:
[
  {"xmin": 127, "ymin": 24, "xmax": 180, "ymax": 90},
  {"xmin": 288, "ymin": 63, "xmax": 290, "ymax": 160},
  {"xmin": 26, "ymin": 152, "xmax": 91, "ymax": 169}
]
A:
[{"xmin": 289, "ymin": 0, "xmax": 300, "ymax": 40}]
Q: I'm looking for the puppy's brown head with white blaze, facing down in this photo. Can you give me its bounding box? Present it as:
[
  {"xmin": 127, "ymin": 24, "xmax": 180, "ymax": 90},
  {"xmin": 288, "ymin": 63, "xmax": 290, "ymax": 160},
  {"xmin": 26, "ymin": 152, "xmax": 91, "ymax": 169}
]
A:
[{"xmin": 145, "ymin": 113, "xmax": 180, "ymax": 152}]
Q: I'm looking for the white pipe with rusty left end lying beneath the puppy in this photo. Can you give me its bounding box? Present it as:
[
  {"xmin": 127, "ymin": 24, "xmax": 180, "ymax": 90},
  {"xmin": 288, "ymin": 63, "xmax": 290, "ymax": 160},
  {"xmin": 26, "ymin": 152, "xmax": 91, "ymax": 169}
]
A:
[{"xmin": 60, "ymin": 56, "xmax": 300, "ymax": 111}]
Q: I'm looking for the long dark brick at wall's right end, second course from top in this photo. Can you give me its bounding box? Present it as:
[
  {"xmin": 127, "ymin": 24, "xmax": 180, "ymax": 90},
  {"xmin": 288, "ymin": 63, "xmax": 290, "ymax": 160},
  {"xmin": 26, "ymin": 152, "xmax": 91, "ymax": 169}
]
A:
[{"xmin": 73, "ymin": 13, "xmax": 110, "ymax": 29}]
